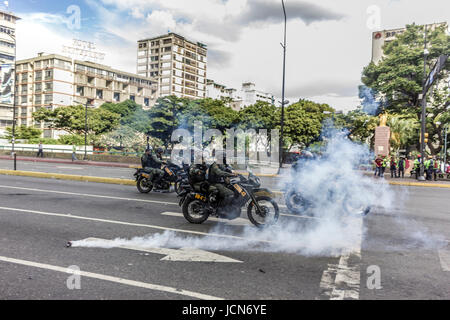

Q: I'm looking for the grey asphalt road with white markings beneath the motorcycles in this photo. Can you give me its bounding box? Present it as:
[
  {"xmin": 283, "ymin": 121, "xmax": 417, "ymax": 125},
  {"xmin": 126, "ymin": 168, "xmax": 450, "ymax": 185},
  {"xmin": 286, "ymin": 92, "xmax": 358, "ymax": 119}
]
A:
[{"xmin": 0, "ymin": 176, "xmax": 450, "ymax": 300}]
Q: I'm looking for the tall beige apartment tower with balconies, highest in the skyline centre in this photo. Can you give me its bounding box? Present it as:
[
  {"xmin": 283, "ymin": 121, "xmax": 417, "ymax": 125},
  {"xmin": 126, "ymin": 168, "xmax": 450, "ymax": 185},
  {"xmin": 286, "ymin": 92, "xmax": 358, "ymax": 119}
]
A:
[{"xmin": 137, "ymin": 33, "xmax": 207, "ymax": 99}]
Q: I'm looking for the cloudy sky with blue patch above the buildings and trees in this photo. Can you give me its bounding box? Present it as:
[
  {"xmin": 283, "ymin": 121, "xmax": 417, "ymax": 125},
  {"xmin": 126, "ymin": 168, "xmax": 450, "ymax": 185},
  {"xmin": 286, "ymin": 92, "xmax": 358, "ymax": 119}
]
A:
[{"xmin": 7, "ymin": 0, "xmax": 450, "ymax": 111}]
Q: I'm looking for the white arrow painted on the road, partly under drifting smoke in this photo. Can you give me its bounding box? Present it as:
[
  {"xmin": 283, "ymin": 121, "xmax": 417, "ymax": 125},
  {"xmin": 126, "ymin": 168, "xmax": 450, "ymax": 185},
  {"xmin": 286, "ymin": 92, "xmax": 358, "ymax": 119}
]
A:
[{"xmin": 79, "ymin": 238, "xmax": 242, "ymax": 263}]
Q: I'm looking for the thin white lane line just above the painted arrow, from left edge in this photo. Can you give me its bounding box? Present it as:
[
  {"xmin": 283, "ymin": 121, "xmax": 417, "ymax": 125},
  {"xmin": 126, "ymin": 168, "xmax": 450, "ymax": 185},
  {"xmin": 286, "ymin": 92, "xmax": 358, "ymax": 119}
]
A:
[{"xmin": 0, "ymin": 207, "xmax": 275, "ymax": 243}]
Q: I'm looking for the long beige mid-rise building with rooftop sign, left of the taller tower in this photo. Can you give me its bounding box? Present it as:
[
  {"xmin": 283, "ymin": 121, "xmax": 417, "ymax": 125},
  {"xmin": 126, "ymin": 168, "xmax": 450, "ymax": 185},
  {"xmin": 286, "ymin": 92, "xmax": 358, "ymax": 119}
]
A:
[{"xmin": 15, "ymin": 53, "xmax": 158, "ymax": 138}]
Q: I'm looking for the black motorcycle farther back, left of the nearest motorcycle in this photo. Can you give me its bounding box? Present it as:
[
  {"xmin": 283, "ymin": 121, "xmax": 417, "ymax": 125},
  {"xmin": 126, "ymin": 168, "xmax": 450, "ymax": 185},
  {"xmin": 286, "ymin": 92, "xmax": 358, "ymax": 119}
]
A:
[{"xmin": 134, "ymin": 163, "xmax": 183, "ymax": 193}]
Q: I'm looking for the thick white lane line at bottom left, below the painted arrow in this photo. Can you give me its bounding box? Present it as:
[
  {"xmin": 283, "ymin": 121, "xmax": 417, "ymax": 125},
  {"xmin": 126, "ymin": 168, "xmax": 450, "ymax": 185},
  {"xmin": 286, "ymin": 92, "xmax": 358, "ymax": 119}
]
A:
[{"xmin": 0, "ymin": 256, "xmax": 223, "ymax": 300}]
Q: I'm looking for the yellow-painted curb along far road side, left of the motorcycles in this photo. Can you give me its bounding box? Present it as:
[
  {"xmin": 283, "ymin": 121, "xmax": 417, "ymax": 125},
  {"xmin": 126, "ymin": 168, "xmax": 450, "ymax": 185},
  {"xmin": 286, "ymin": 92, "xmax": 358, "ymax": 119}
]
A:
[{"xmin": 0, "ymin": 170, "xmax": 136, "ymax": 186}]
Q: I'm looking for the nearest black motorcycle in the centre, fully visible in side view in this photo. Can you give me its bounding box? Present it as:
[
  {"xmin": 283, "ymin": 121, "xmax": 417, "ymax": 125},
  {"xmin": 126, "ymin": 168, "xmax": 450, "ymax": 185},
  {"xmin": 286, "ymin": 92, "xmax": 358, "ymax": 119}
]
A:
[{"xmin": 179, "ymin": 173, "xmax": 279, "ymax": 228}]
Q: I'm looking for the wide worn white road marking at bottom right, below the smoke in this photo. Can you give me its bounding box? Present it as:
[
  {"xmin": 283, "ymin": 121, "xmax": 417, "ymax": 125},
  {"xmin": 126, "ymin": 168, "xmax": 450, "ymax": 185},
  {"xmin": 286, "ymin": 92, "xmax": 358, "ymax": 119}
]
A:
[{"xmin": 320, "ymin": 217, "xmax": 363, "ymax": 300}]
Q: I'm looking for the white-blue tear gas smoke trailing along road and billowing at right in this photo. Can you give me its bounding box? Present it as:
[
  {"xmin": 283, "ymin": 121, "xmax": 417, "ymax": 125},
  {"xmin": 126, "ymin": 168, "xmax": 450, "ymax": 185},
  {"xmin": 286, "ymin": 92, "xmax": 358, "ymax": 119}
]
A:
[{"xmin": 73, "ymin": 132, "xmax": 446, "ymax": 256}]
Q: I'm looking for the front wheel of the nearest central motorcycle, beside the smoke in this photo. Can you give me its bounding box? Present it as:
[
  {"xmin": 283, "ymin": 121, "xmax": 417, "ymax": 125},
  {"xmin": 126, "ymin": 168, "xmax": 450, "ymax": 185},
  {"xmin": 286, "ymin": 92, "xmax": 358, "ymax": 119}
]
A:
[{"xmin": 247, "ymin": 197, "xmax": 280, "ymax": 228}]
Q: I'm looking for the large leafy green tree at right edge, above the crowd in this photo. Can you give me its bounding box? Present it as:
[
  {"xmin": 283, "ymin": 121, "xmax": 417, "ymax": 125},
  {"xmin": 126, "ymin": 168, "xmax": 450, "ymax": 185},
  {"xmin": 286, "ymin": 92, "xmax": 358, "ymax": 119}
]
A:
[{"xmin": 362, "ymin": 24, "xmax": 450, "ymax": 153}]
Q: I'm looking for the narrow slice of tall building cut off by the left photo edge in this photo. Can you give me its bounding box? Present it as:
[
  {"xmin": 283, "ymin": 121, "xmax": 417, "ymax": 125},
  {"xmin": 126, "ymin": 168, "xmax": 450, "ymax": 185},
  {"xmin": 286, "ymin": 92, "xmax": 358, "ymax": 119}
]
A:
[{"xmin": 0, "ymin": 10, "xmax": 20, "ymax": 128}]
